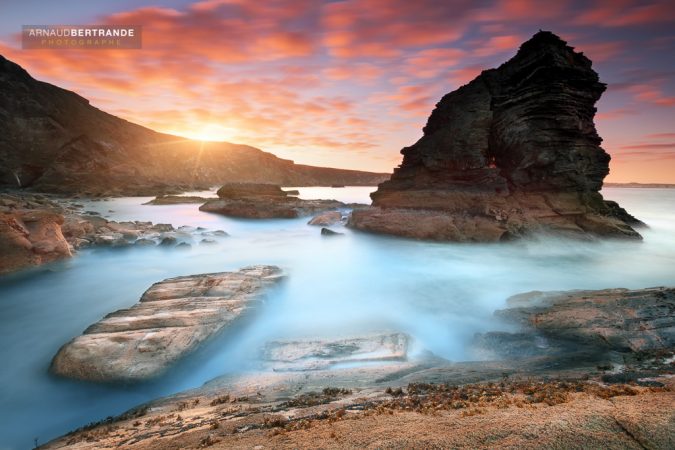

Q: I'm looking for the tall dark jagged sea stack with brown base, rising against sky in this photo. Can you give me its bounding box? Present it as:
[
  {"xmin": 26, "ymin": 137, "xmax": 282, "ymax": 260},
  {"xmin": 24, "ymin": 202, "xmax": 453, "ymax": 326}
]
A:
[{"xmin": 351, "ymin": 32, "xmax": 641, "ymax": 241}]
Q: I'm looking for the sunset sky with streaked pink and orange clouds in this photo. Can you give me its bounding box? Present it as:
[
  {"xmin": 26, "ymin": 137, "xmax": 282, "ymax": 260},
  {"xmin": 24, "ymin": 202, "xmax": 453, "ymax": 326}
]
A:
[{"xmin": 0, "ymin": 0, "xmax": 675, "ymax": 183}]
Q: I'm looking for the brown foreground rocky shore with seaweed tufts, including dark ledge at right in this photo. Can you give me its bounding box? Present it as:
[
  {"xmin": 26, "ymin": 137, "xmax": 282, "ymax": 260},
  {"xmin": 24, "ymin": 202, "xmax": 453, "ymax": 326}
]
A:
[{"xmin": 44, "ymin": 288, "xmax": 675, "ymax": 449}]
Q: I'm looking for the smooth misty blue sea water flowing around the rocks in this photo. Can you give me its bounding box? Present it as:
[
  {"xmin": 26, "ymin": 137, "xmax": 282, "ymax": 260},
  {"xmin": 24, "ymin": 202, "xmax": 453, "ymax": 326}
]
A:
[{"xmin": 0, "ymin": 187, "xmax": 675, "ymax": 449}]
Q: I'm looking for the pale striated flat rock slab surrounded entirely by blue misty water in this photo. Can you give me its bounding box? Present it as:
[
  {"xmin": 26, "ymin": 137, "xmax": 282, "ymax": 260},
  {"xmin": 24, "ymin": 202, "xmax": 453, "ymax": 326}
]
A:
[{"xmin": 51, "ymin": 266, "xmax": 282, "ymax": 382}]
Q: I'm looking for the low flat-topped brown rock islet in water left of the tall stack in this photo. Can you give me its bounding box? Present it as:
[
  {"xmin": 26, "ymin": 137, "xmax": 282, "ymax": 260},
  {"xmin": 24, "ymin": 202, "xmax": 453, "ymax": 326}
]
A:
[{"xmin": 199, "ymin": 183, "xmax": 347, "ymax": 219}]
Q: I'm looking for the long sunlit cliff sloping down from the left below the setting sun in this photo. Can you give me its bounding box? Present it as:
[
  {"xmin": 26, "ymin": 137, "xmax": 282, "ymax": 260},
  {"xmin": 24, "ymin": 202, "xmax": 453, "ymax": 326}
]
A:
[{"xmin": 0, "ymin": 56, "xmax": 387, "ymax": 195}]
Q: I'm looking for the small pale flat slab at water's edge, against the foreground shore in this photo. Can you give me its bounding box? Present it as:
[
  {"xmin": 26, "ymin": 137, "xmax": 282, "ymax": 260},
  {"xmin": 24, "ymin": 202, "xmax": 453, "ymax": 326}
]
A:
[{"xmin": 262, "ymin": 332, "xmax": 411, "ymax": 371}]
